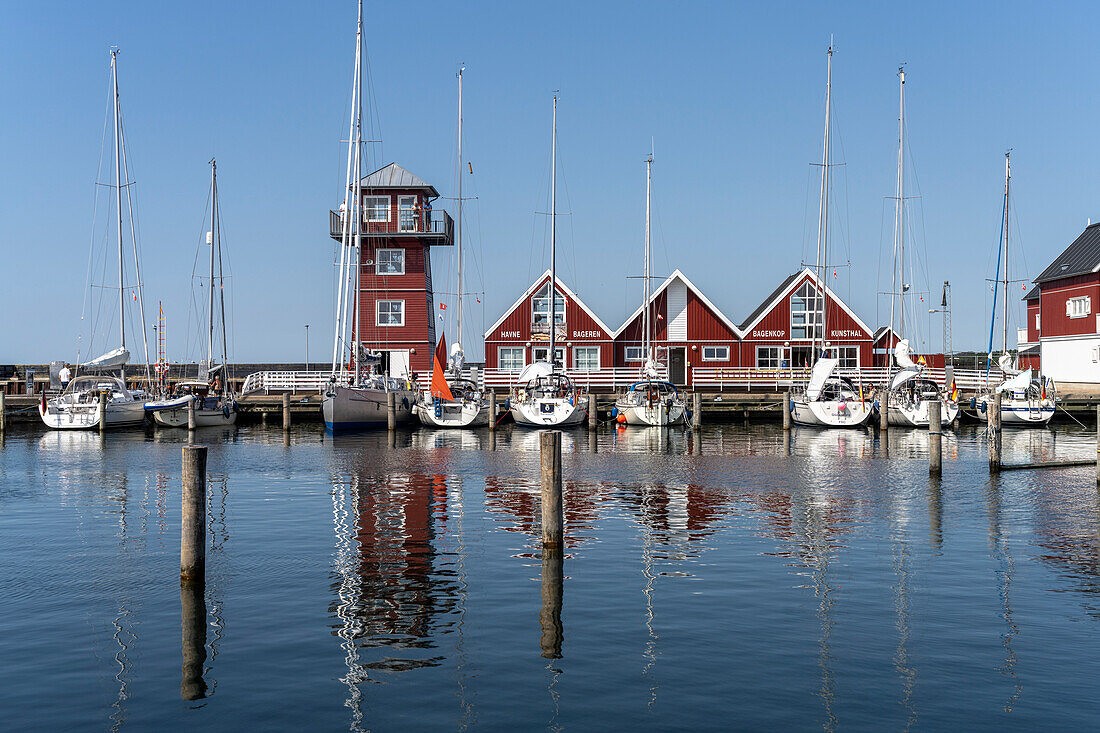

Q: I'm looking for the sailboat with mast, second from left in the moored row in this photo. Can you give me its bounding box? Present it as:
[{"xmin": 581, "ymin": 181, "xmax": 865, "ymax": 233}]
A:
[{"xmin": 145, "ymin": 158, "xmax": 237, "ymax": 427}]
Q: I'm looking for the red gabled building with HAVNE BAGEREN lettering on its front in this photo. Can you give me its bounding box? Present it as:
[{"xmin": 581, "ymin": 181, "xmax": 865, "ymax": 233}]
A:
[{"xmin": 485, "ymin": 270, "xmax": 615, "ymax": 376}]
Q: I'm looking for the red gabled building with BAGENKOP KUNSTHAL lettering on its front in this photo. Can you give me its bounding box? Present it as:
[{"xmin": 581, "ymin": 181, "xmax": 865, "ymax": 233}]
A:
[{"xmin": 739, "ymin": 267, "xmax": 872, "ymax": 369}]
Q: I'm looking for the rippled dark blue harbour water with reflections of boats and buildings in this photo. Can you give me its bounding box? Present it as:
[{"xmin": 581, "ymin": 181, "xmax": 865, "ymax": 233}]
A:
[{"xmin": 0, "ymin": 424, "xmax": 1100, "ymax": 731}]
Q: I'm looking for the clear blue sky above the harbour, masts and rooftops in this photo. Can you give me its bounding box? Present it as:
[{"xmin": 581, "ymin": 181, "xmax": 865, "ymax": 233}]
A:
[{"xmin": 0, "ymin": 0, "xmax": 1100, "ymax": 363}]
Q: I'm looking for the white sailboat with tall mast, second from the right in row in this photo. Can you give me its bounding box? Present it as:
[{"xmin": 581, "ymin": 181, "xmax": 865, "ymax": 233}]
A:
[{"xmin": 879, "ymin": 68, "xmax": 959, "ymax": 427}]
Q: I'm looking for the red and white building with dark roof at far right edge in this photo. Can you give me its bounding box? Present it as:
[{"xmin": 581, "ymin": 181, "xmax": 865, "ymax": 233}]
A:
[{"xmin": 1021, "ymin": 222, "xmax": 1100, "ymax": 383}]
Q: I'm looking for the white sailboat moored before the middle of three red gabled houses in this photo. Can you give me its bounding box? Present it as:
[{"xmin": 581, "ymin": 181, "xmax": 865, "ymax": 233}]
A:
[{"xmin": 612, "ymin": 155, "xmax": 688, "ymax": 426}]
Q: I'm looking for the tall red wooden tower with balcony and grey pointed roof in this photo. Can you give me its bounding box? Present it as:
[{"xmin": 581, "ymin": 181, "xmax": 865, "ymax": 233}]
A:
[{"xmin": 329, "ymin": 163, "xmax": 454, "ymax": 376}]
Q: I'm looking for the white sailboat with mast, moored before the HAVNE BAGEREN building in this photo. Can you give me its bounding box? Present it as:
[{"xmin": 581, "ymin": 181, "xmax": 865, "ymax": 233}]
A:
[{"xmin": 509, "ymin": 95, "xmax": 585, "ymax": 427}]
